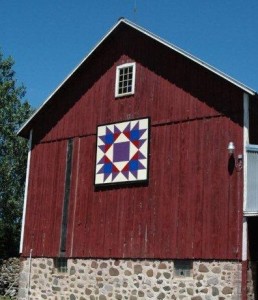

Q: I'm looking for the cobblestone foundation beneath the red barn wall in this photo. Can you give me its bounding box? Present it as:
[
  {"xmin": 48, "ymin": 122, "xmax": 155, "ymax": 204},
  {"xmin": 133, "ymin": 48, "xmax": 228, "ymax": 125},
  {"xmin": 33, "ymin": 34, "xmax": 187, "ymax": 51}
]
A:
[{"xmin": 19, "ymin": 258, "xmax": 241, "ymax": 300}]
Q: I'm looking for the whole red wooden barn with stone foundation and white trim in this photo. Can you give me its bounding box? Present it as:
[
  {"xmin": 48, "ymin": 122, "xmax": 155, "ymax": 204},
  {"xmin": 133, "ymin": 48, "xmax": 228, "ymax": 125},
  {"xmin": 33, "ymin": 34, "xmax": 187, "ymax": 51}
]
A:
[{"xmin": 19, "ymin": 19, "xmax": 258, "ymax": 300}]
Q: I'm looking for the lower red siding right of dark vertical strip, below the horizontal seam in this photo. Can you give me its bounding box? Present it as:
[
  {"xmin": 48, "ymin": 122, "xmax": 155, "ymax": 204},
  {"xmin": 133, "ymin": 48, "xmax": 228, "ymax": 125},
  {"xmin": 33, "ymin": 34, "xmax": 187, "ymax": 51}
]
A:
[{"xmin": 67, "ymin": 118, "xmax": 241, "ymax": 258}]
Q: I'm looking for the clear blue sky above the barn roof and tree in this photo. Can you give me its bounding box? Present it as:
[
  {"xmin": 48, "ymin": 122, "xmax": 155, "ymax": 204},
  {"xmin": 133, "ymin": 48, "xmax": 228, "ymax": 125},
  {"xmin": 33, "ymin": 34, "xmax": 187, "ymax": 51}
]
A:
[{"xmin": 0, "ymin": 0, "xmax": 258, "ymax": 108}]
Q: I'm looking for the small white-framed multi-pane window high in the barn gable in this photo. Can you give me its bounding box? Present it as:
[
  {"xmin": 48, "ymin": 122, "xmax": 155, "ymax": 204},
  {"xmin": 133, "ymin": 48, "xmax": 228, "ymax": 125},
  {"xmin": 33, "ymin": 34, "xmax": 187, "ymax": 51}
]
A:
[{"xmin": 115, "ymin": 63, "xmax": 135, "ymax": 97}]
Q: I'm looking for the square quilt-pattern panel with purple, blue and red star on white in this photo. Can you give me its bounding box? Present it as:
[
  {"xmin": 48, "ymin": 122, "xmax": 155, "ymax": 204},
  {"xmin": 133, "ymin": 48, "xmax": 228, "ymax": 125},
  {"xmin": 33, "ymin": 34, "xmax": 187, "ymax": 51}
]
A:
[{"xmin": 95, "ymin": 118, "xmax": 150, "ymax": 185}]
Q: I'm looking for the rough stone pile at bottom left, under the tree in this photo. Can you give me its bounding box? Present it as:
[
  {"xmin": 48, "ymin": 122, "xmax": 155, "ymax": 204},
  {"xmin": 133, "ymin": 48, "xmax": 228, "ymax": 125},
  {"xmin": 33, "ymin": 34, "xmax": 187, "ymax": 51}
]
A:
[{"xmin": 0, "ymin": 257, "xmax": 20, "ymax": 299}]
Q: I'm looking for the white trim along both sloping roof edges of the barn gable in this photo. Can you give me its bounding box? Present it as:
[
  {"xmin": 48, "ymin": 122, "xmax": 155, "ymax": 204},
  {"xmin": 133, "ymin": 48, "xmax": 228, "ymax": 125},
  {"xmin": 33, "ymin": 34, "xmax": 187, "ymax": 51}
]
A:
[{"xmin": 17, "ymin": 18, "xmax": 256, "ymax": 134}]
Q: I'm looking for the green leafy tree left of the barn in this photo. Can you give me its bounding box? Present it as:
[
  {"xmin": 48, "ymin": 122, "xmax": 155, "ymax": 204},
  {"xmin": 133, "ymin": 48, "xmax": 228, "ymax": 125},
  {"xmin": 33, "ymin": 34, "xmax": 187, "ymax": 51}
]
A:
[{"xmin": 0, "ymin": 52, "xmax": 32, "ymax": 257}]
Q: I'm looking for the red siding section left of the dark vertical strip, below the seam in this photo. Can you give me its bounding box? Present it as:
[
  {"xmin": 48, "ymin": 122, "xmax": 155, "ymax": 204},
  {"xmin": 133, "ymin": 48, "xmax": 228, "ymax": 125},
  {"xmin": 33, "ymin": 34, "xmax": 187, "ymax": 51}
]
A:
[{"xmin": 23, "ymin": 141, "xmax": 66, "ymax": 256}]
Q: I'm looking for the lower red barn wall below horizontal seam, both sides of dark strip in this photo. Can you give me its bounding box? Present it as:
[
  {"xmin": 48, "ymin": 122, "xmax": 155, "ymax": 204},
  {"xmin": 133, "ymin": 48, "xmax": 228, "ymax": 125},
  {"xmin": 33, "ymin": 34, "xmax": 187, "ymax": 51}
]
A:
[{"xmin": 24, "ymin": 113, "xmax": 242, "ymax": 259}]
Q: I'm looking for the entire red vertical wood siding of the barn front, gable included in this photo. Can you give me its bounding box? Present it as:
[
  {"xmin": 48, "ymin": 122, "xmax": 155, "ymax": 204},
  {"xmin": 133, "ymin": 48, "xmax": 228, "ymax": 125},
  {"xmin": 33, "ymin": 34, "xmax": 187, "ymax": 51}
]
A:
[{"xmin": 23, "ymin": 26, "xmax": 243, "ymax": 259}]
